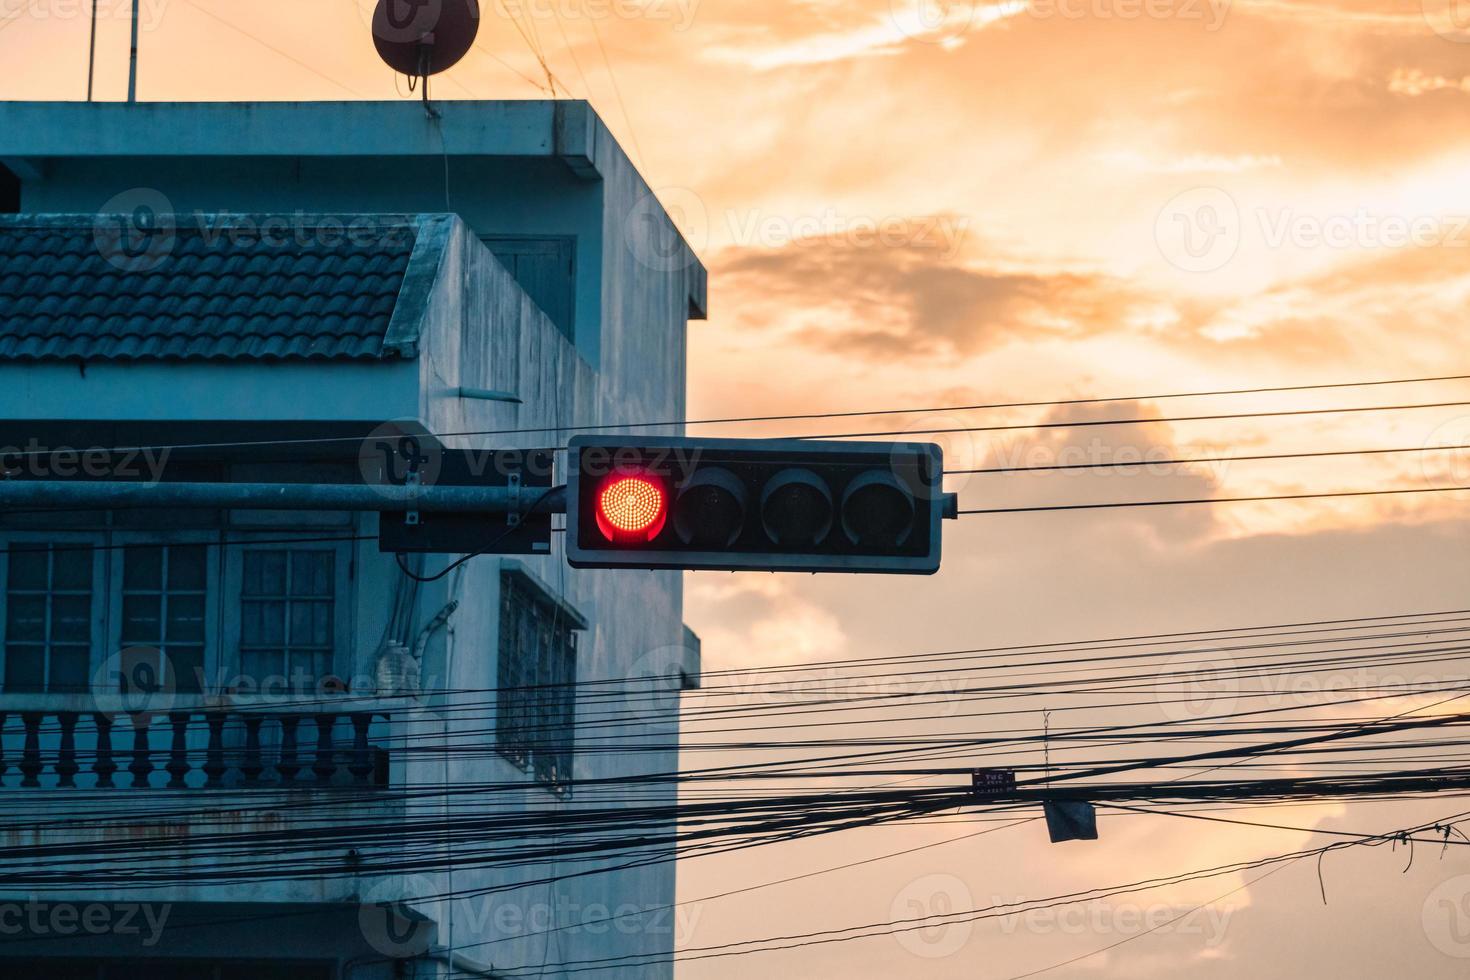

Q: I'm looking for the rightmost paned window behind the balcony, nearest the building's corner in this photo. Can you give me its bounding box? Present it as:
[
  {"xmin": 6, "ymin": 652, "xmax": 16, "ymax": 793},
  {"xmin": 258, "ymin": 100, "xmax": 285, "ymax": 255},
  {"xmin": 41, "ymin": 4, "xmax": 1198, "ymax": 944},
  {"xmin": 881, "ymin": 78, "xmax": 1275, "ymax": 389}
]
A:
[{"xmin": 240, "ymin": 548, "xmax": 337, "ymax": 689}]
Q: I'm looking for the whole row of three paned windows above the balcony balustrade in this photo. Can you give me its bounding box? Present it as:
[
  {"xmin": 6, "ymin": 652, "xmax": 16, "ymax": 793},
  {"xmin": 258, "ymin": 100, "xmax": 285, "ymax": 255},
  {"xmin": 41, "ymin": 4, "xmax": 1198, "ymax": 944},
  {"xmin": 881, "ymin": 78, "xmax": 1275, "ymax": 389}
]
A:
[{"xmin": 0, "ymin": 529, "xmax": 351, "ymax": 695}]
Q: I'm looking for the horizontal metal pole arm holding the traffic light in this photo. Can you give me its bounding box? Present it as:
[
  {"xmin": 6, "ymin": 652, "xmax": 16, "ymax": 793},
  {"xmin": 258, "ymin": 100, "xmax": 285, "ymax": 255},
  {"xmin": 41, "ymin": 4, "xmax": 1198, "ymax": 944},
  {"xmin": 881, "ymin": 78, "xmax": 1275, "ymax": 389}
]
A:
[{"xmin": 0, "ymin": 480, "xmax": 566, "ymax": 514}]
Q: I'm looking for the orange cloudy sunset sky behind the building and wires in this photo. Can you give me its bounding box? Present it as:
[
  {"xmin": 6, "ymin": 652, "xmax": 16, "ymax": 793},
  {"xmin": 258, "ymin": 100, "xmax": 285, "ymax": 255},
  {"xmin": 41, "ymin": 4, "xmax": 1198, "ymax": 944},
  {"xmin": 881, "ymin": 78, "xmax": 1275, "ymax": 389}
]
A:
[{"xmin": 0, "ymin": 0, "xmax": 1470, "ymax": 980}]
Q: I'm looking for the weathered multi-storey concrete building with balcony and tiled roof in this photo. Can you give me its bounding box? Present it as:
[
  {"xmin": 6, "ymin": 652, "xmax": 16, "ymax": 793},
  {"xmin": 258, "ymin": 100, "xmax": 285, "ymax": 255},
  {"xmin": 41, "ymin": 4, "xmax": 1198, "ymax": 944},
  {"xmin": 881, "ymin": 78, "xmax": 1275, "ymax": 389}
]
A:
[{"xmin": 0, "ymin": 101, "xmax": 706, "ymax": 980}]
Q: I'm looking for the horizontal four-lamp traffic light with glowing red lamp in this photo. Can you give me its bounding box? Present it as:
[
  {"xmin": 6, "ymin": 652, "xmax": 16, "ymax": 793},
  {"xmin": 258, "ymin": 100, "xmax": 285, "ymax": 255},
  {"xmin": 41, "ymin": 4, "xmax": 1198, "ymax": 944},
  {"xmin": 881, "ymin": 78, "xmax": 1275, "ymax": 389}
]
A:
[{"xmin": 566, "ymin": 436, "xmax": 950, "ymax": 574}]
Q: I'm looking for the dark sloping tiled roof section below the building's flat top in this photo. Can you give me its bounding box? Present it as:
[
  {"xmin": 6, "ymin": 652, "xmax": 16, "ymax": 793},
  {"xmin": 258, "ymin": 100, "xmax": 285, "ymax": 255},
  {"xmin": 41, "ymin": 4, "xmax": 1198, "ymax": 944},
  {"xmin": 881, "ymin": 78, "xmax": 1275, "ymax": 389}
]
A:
[{"xmin": 0, "ymin": 215, "xmax": 438, "ymax": 360}]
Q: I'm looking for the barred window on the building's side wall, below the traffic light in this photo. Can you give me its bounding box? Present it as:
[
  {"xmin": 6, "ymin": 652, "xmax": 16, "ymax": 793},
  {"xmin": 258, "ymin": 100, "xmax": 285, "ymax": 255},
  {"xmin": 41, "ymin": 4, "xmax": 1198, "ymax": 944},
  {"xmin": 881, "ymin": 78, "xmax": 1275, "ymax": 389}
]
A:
[{"xmin": 495, "ymin": 567, "xmax": 587, "ymax": 788}]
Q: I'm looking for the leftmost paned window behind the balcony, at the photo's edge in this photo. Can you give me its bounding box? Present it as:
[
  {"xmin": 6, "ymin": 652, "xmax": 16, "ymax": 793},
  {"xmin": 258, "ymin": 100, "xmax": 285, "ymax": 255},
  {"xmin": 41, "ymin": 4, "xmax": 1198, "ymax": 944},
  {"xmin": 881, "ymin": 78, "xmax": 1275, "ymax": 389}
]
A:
[{"xmin": 4, "ymin": 542, "xmax": 96, "ymax": 692}]
